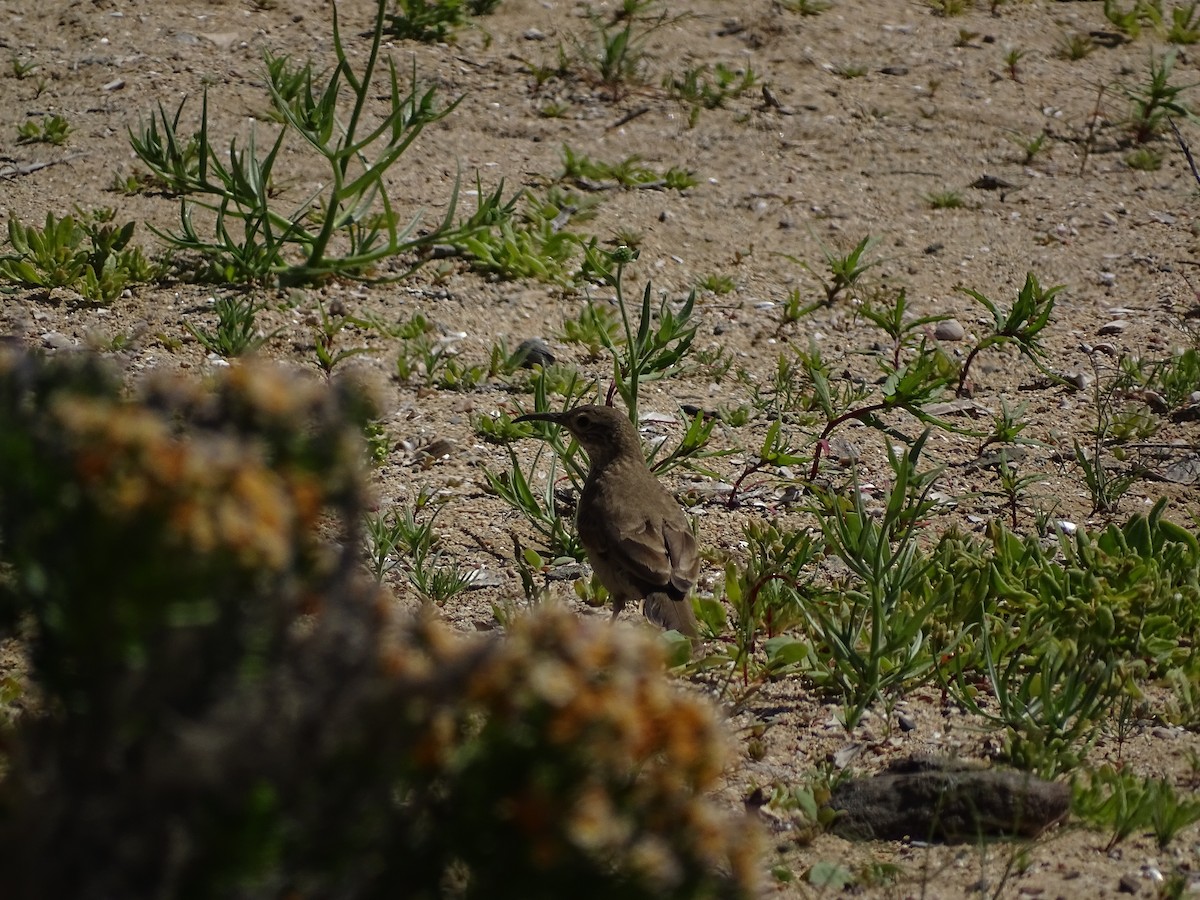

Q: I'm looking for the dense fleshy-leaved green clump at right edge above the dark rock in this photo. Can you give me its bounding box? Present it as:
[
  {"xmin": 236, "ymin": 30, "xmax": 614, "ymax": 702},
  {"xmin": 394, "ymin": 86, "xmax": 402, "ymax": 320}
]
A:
[{"xmin": 938, "ymin": 503, "xmax": 1200, "ymax": 775}]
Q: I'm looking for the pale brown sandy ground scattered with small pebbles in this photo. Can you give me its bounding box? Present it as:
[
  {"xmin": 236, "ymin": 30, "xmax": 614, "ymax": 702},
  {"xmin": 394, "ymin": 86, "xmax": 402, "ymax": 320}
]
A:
[{"xmin": 0, "ymin": 0, "xmax": 1200, "ymax": 898}]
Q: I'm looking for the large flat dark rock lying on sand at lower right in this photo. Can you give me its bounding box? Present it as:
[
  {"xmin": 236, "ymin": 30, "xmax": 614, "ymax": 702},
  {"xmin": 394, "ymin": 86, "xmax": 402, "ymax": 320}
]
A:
[{"xmin": 829, "ymin": 757, "xmax": 1070, "ymax": 842}]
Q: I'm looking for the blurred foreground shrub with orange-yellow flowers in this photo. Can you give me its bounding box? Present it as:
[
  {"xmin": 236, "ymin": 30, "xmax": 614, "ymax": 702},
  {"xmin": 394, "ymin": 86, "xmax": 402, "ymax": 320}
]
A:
[{"xmin": 0, "ymin": 347, "xmax": 756, "ymax": 900}]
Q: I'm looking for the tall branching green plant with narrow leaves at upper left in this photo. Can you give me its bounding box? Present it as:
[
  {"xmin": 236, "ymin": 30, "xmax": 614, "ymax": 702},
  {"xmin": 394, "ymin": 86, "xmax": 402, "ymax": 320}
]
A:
[{"xmin": 130, "ymin": 0, "xmax": 501, "ymax": 284}]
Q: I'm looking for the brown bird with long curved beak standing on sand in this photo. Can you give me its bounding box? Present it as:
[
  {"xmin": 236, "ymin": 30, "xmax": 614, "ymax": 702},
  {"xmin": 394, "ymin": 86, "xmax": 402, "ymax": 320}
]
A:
[{"xmin": 515, "ymin": 406, "xmax": 700, "ymax": 638}]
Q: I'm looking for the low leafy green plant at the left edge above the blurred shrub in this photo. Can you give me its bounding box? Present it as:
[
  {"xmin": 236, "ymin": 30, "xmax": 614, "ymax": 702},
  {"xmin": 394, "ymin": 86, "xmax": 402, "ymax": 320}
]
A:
[{"xmin": 0, "ymin": 210, "xmax": 161, "ymax": 304}]
